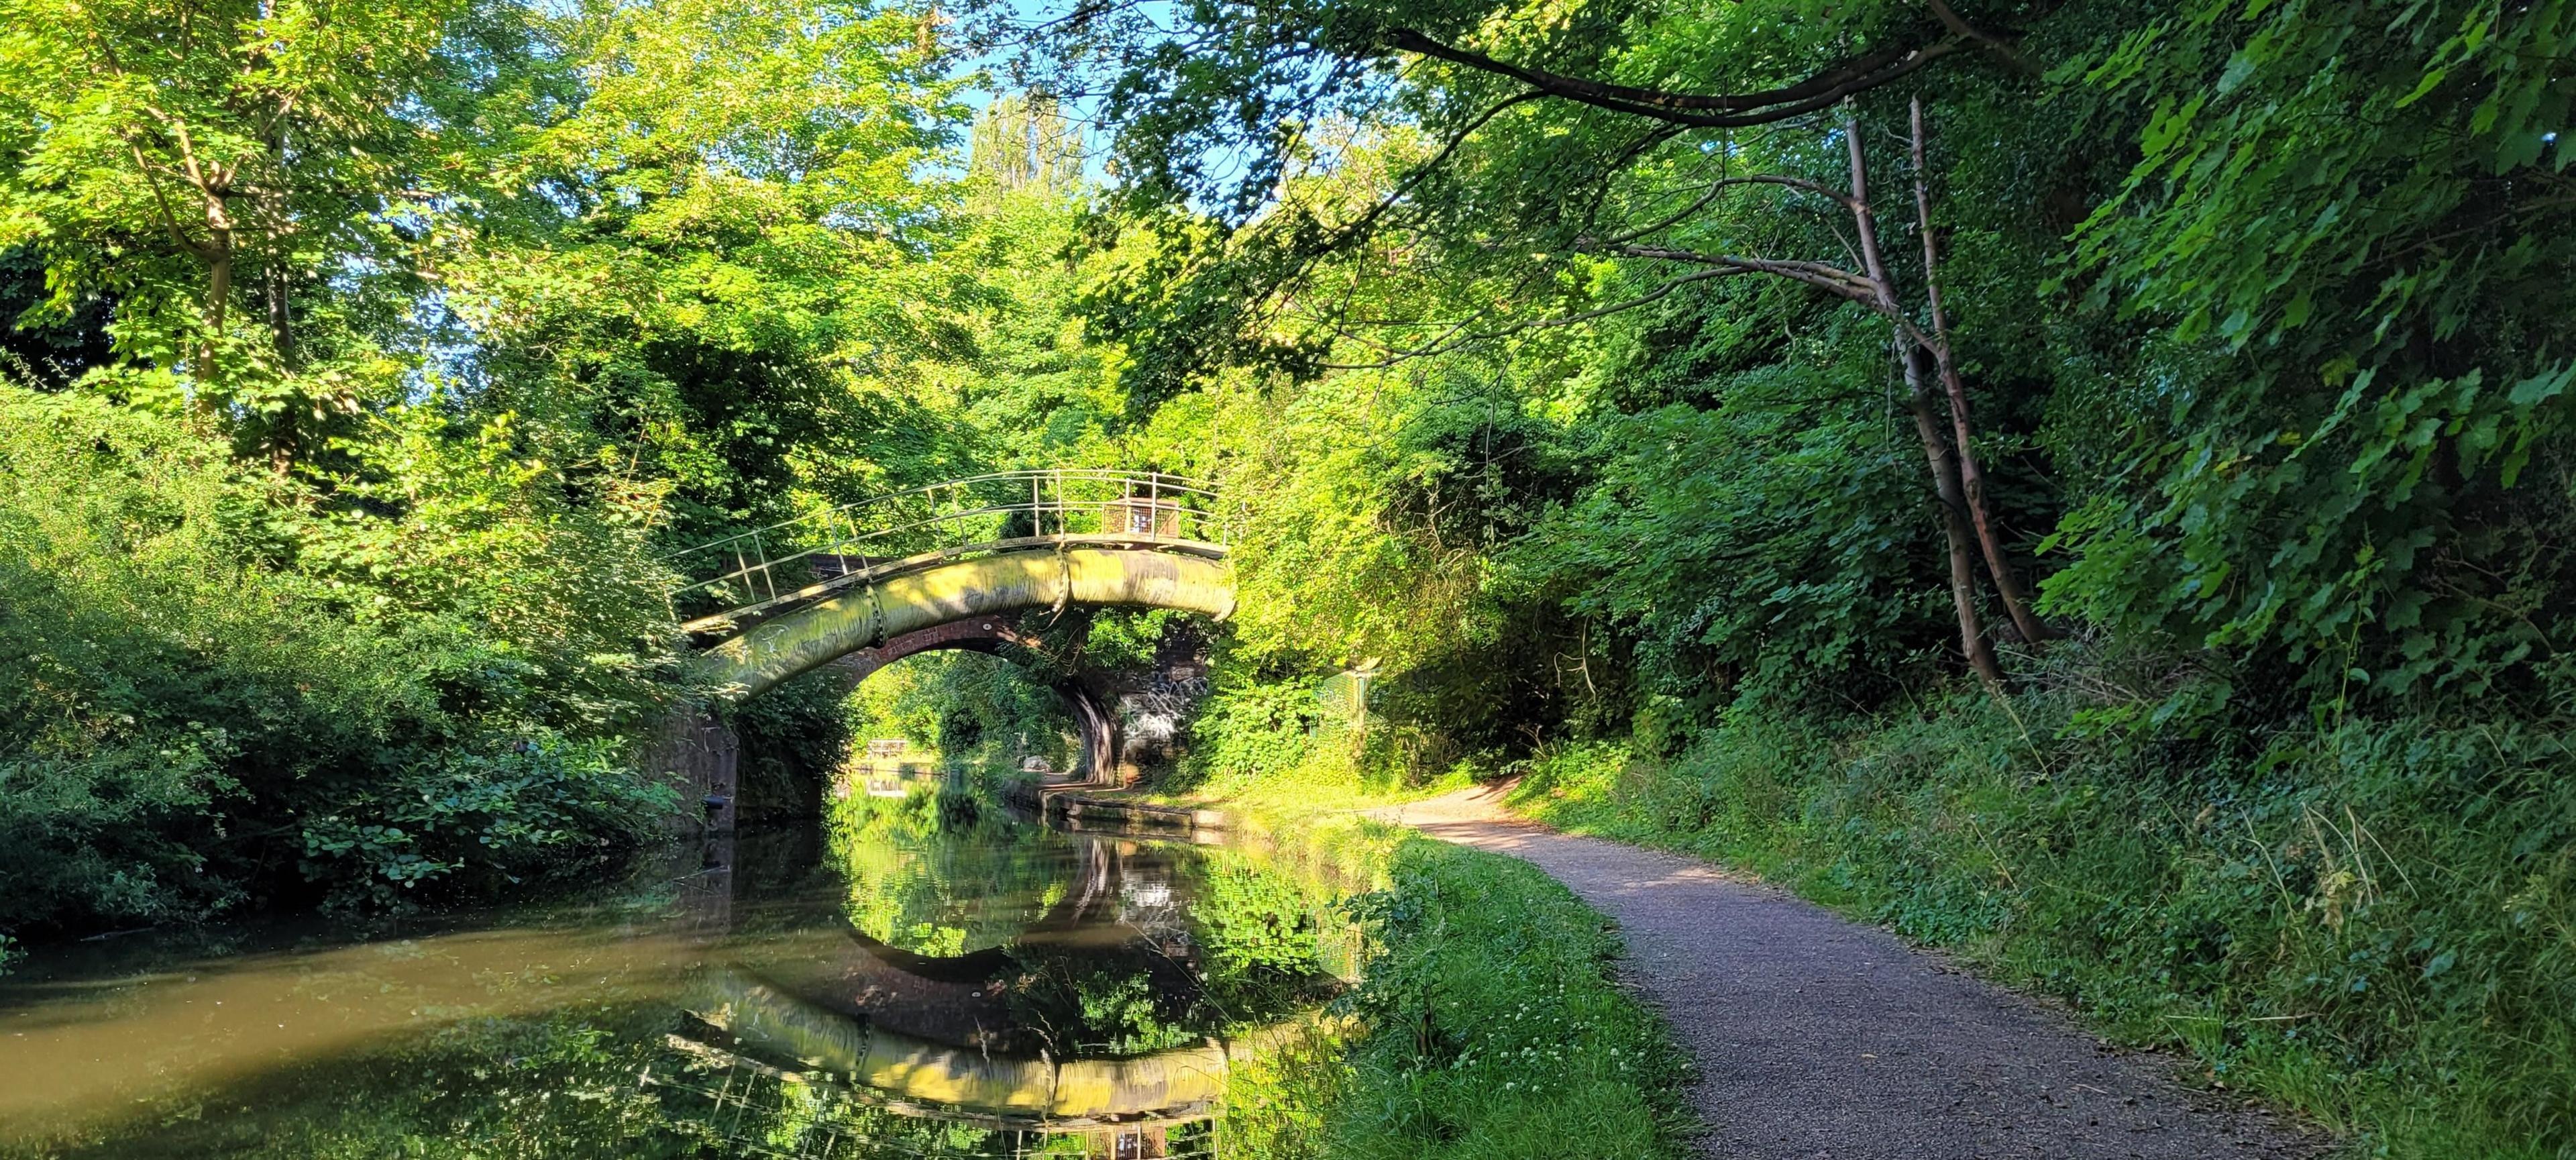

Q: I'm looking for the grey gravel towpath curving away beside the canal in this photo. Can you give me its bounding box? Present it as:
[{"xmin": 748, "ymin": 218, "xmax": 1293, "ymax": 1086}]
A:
[{"xmin": 1371, "ymin": 789, "xmax": 2324, "ymax": 1160}]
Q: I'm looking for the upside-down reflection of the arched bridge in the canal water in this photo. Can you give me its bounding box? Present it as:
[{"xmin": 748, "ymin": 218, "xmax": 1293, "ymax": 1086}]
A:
[{"xmin": 639, "ymin": 838, "xmax": 1350, "ymax": 1160}]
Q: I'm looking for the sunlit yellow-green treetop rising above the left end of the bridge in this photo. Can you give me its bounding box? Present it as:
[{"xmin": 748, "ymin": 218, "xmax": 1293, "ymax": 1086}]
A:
[{"xmin": 448, "ymin": 0, "xmax": 984, "ymax": 541}]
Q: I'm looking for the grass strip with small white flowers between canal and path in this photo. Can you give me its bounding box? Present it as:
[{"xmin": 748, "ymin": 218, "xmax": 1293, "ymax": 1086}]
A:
[{"xmin": 1226, "ymin": 823, "xmax": 1687, "ymax": 1160}]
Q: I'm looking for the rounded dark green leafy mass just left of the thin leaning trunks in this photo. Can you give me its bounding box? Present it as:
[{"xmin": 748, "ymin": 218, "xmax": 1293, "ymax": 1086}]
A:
[{"xmin": 1505, "ymin": 381, "xmax": 1945, "ymax": 711}]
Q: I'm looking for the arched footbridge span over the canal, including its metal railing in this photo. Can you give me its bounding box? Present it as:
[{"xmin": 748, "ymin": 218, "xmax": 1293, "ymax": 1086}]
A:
[{"xmin": 669, "ymin": 469, "xmax": 1234, "ymax": 701}]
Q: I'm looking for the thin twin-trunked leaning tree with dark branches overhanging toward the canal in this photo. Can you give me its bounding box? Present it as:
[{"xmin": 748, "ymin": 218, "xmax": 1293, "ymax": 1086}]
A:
[{"xmin": 1014, "ymin": 3, "xmax": 2048, "ymax": 683}]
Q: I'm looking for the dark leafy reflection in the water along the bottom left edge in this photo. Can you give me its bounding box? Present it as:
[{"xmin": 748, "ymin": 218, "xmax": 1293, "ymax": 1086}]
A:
[{"xmin": 0, "ymin": 1005, "xmax": 1211, "ymax": 1160}]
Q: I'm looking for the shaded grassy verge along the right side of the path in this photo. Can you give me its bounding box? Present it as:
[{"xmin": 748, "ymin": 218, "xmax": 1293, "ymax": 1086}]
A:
[{"xmin": 1515, "ymin": 696, "xmax": 2576, "ymax": 1160}]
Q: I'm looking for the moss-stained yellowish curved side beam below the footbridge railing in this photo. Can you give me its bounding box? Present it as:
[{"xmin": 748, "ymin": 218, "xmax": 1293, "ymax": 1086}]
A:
[{"xmin": 690, "ymin": 547, "xmax": 1234, "ymax": 701}]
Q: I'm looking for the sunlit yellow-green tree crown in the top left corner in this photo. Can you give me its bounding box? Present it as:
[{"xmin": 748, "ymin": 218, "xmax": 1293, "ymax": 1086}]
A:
[{"xmin": 0, "ymin": 0, "xmax": 492, "ymax": 469}]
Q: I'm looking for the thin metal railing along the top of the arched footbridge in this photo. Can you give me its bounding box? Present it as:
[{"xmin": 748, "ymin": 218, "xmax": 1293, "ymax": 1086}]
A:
[{"xmin": 665, "ymin": 469, "xmax": 1229, "ymax": 631}]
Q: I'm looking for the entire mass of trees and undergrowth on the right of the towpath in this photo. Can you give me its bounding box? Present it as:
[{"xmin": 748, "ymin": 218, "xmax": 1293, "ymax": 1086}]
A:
[{"xmin": 1046, "ymin": 0, "xmax": 2576, "ymax": 1157}]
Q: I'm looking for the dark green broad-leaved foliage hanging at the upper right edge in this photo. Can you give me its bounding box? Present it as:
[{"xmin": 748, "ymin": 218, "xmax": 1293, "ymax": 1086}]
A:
[{"xmin": 2053, "ymin": 3, "xmax": 2576, "ymax": 701}]
